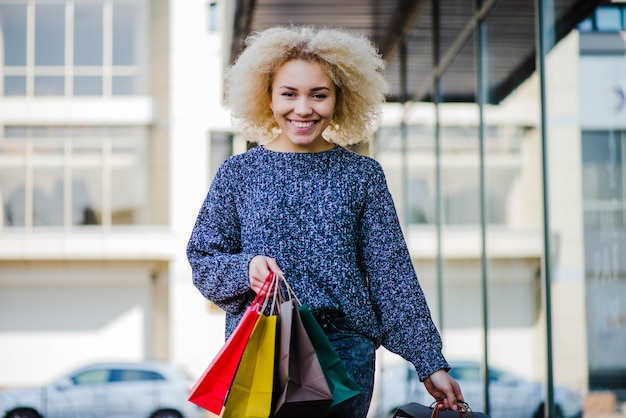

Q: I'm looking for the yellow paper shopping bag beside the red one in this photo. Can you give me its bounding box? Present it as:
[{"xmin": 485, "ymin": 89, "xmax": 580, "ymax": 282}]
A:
[{"xmin": 223, "ymin": 306, "xmax": 276, "ymax": 418}]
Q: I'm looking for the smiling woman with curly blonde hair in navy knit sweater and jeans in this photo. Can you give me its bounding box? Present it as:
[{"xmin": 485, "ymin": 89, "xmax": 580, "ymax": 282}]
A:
[{"xmin": 187, "ymin": 27, "xmax": 463, "ymax": 418}]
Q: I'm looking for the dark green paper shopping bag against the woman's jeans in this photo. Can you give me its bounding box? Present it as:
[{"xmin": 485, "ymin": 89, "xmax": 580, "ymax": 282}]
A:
[{"xmin": 298, "ymin": 304, "xmax": 361, "ymax": 414}]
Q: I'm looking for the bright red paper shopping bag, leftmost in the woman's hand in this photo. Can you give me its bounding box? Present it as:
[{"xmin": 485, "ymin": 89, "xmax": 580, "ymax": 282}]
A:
[{"xmin": 189, "ymin": 272, "xmax": 274, "ymax": 415}]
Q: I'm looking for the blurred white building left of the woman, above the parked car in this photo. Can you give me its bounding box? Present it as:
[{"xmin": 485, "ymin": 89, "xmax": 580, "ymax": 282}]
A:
[{"xmin": 0, "ymin": 0, "xmax": 231, "ymax": 386}]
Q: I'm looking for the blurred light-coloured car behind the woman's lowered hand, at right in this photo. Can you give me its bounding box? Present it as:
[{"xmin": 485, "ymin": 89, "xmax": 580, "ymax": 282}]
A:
[{"xmin": 374, "ymin": 361, "xmax": 583, "ymax": 418}]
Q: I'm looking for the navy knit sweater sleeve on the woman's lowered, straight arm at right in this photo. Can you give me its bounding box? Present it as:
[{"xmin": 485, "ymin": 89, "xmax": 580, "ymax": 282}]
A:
[{"xmin": 360, "ymin": 164, "xmax": 449, "ymax": 380}]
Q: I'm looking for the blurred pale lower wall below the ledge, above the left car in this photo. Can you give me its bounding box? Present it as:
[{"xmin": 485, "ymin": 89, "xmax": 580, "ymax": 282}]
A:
[{"xmin": 0, "ymin": 263, "xmax": 152, "ymax": 387}]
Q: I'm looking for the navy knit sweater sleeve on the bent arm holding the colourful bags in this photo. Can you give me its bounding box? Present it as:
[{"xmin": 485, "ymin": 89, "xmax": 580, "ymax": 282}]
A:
[{"xmin": 187, "ymin": 161, "xmax": 255, "ymax": 314}]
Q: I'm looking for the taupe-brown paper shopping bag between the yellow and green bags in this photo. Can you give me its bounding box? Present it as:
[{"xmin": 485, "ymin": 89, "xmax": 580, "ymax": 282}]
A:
[{"xmin": 272, "ymin": 299, "xmax": 333, "ymax": 418}]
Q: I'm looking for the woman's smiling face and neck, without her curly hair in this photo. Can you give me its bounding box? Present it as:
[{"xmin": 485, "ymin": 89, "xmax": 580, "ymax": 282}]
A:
[{"xmin": 266, "ymin": 59, "xmax": 337, "ymax": 152}]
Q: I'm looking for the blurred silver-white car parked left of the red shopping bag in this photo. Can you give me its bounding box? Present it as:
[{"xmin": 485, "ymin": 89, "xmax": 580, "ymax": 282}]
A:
[{"xmin": 0, "ymin": 361, "xmax": 206, "ymax": 418}]
